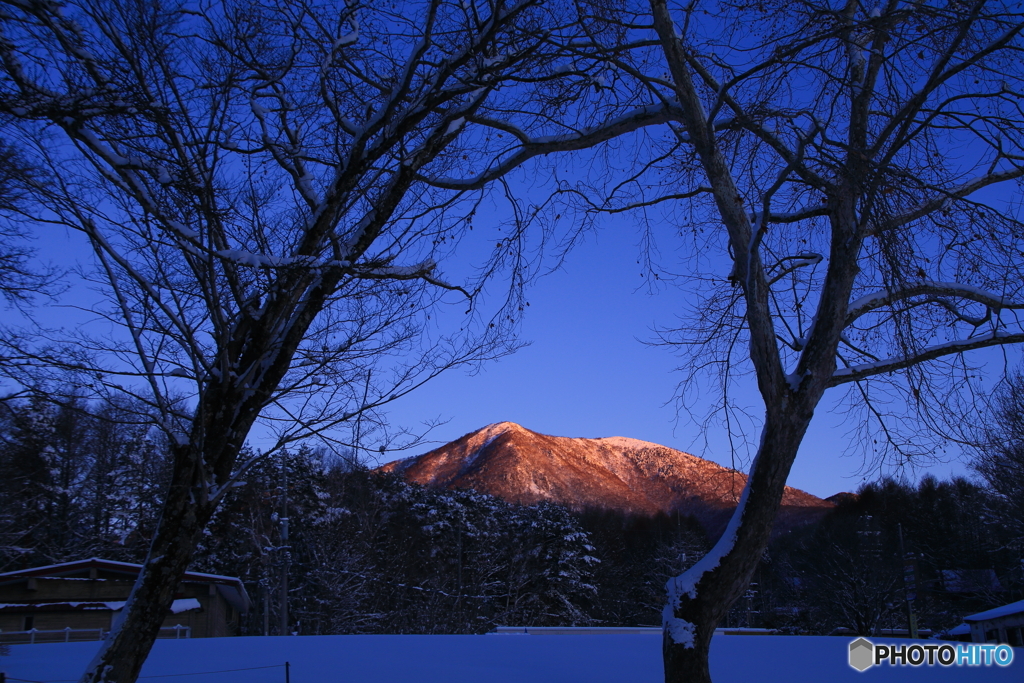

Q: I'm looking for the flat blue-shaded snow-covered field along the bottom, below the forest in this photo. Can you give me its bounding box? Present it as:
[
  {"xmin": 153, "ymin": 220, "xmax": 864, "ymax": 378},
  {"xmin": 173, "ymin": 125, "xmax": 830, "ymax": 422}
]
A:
[{"xmin": 0, "ymin": 634, "xmax": 1024, "ymax": 683}]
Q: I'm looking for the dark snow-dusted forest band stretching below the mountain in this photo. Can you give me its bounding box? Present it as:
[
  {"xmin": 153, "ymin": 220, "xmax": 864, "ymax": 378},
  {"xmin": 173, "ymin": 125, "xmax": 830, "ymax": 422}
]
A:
[{"xmin": 0, "ymin": 394, "xmax": 1024, "ymax": 635}]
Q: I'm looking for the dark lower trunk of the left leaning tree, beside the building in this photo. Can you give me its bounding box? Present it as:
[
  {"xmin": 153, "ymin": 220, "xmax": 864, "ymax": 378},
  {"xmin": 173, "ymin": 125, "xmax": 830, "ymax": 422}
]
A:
[{"xmin": 80, "ymin": 445, "xmax": 213, "ymax": 683}]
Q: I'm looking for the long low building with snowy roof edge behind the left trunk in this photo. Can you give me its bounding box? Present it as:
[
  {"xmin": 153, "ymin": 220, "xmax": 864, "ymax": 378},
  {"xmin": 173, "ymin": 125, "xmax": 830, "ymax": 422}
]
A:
[{"xmin": 0, "ymin": 557, "xmax": 250, "ymax": 643}]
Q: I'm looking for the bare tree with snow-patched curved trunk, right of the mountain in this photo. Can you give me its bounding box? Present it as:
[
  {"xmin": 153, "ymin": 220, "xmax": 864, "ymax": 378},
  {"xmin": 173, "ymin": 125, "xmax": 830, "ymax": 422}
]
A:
[{"xmin": 432, "ymin": 0, "xmax": 1024, "ymax": 682}]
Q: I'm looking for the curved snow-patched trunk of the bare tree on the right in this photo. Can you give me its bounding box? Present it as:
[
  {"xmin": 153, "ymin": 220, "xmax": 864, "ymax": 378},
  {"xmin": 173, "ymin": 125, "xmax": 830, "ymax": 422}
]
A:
[{"xmin": 663, "ymin": 405, "xmax": 816, "ymax": 683}]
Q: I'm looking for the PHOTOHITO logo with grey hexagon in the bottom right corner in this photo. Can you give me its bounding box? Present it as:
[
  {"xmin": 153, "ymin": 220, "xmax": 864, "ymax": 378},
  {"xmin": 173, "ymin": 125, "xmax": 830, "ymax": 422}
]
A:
[{"xmin": 850, "ymin": 638, "xmax": 1014, "ymax": 671}]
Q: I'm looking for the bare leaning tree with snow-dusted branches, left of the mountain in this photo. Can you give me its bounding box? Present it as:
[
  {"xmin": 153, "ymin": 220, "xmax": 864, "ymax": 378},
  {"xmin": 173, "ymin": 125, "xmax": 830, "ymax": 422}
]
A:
[{"xmin": 0, "ymin": 0, "xmax": 598, "ymax": 683}]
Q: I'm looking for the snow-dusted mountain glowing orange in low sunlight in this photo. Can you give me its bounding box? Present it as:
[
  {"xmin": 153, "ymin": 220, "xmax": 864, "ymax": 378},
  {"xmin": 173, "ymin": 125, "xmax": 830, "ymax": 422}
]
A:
[{"xmin": 379, "ymin": 422, "xmax": 833, "ymax": 515}]
